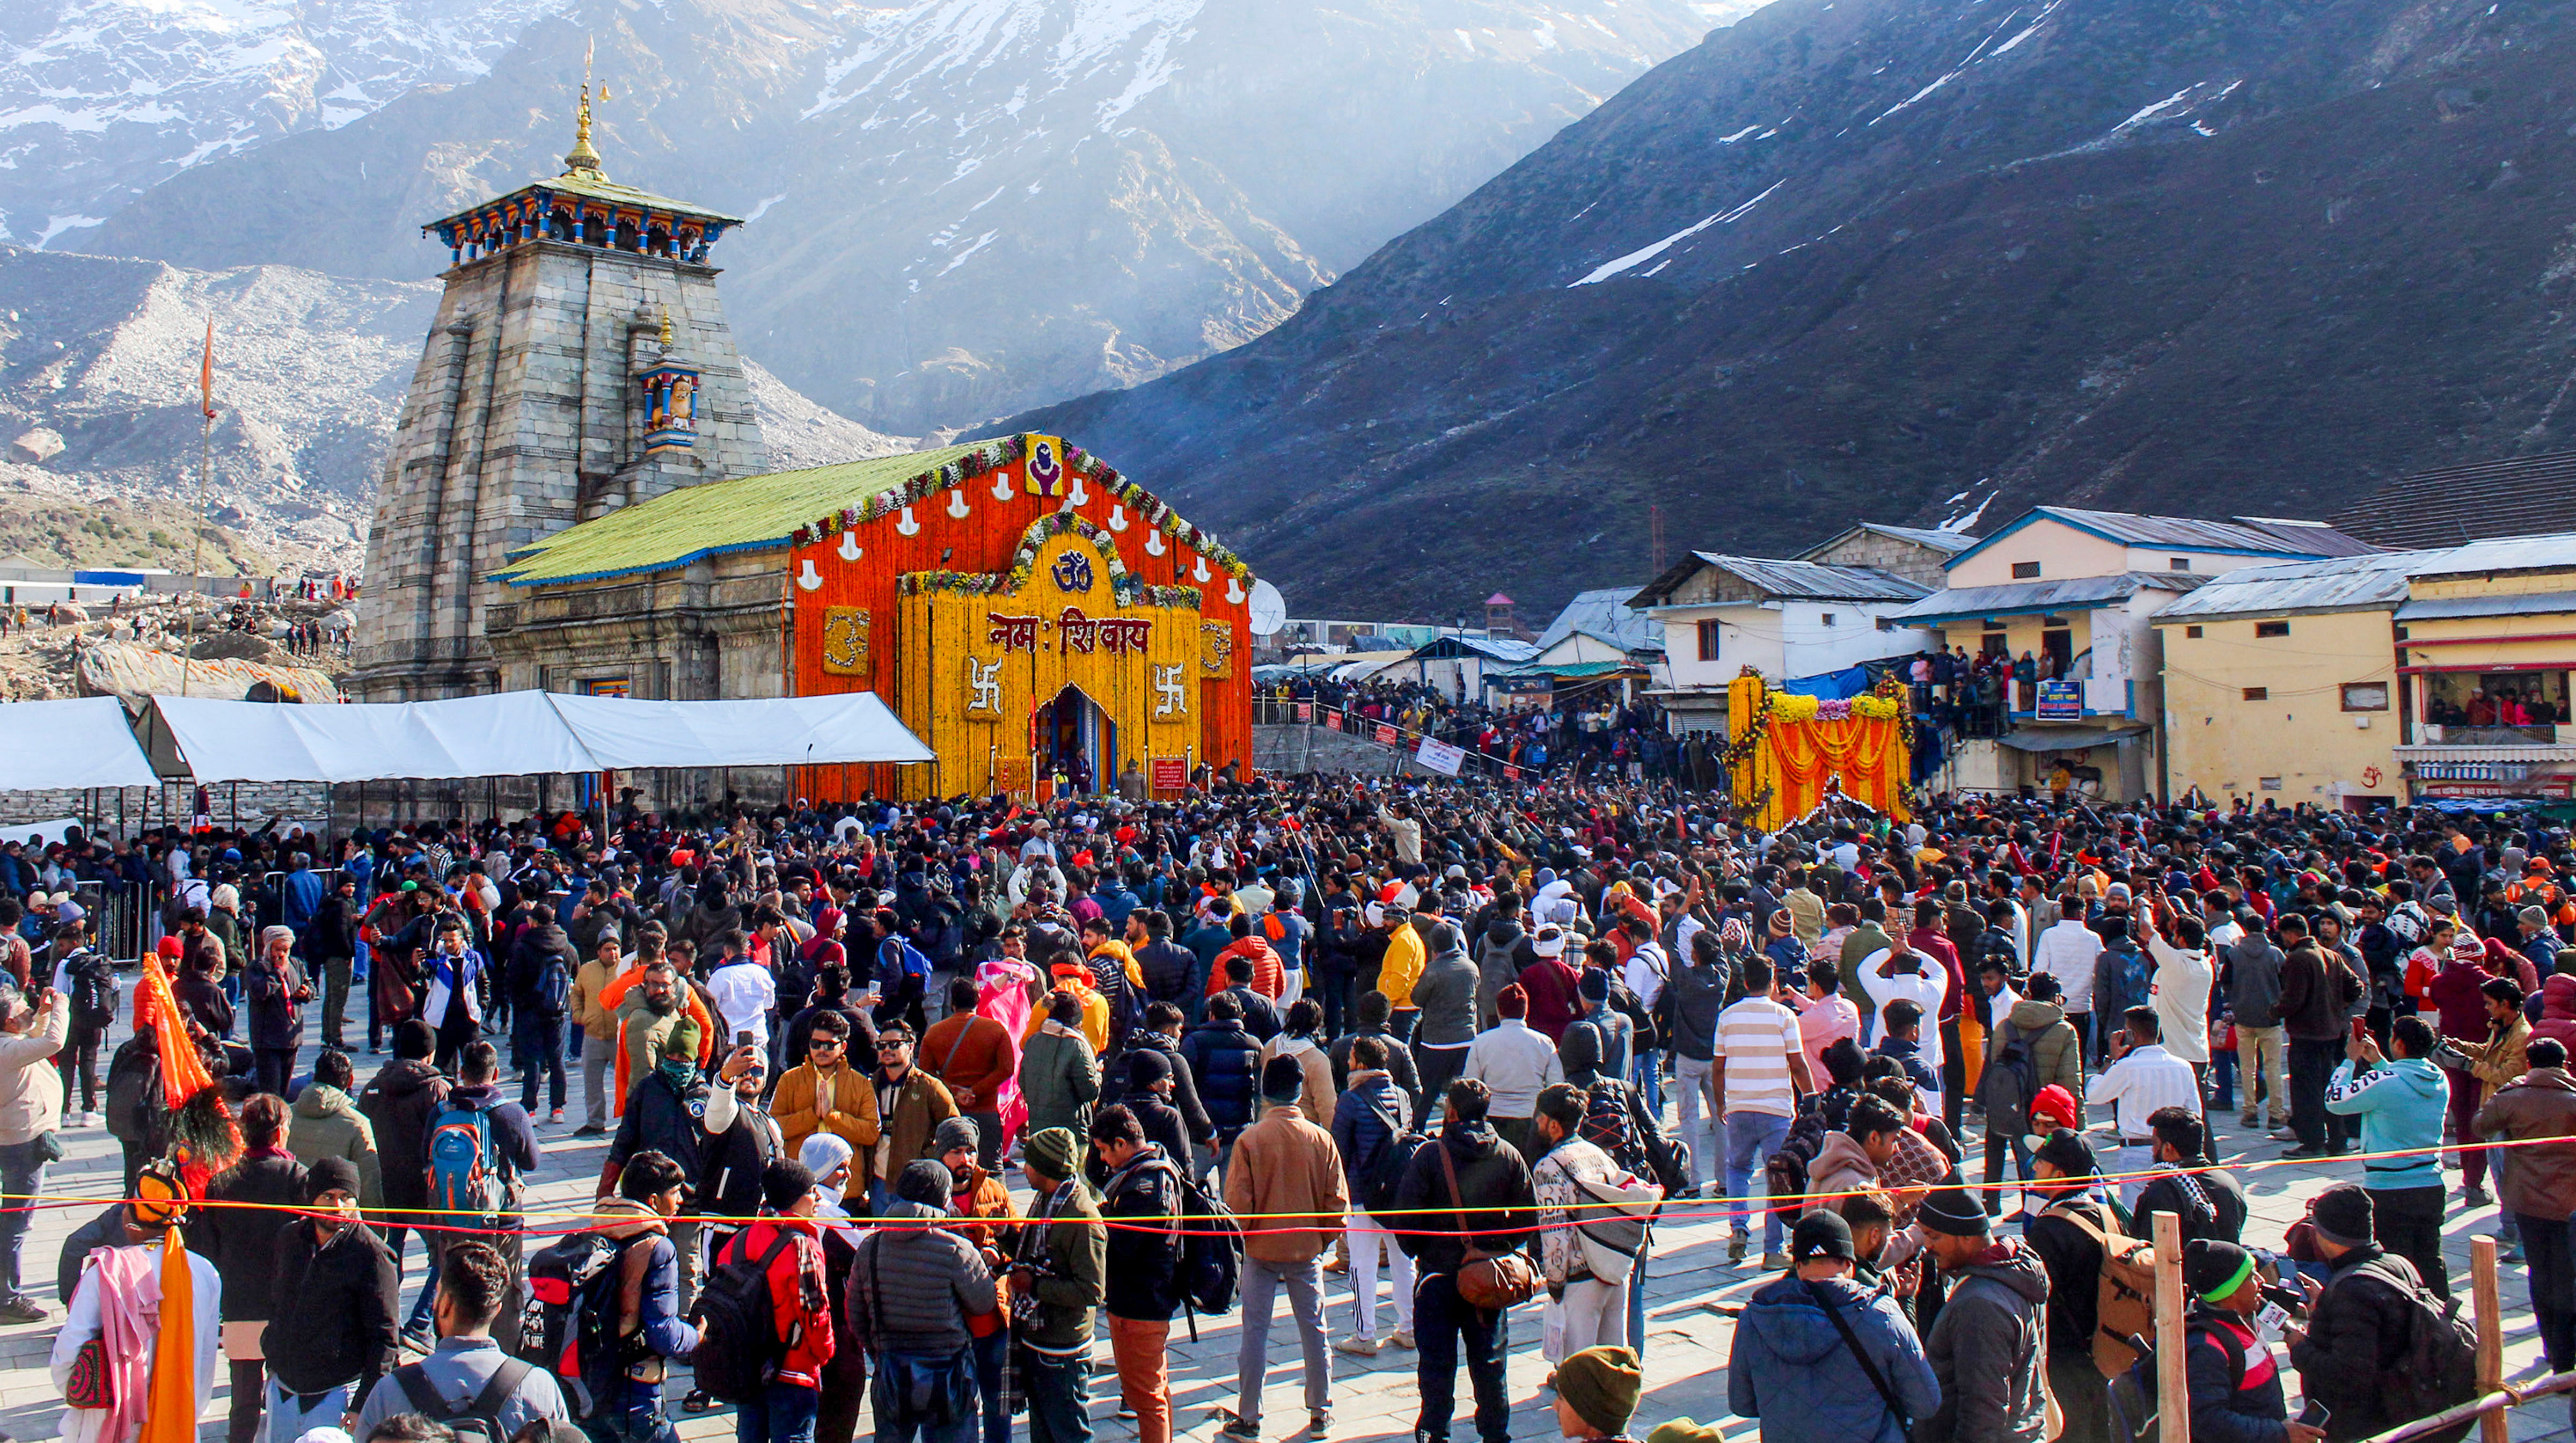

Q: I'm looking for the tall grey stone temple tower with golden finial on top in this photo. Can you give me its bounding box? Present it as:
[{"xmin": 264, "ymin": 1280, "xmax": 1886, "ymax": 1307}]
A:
[{"xmin": 348, "ymin": 85, "xmax": 767, "ymax": 701}]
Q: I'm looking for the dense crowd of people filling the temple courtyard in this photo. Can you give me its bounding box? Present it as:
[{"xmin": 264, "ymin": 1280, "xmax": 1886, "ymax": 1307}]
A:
[{"xmin": 0, "ymin": 778, "xmax": 2576, "ymax": 1443}]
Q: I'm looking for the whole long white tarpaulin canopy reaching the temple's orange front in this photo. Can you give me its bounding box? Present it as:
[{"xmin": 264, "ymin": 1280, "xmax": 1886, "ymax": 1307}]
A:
[{"xmin": 143, "ymin": 690, "xmax": 933, "ymax": 786}]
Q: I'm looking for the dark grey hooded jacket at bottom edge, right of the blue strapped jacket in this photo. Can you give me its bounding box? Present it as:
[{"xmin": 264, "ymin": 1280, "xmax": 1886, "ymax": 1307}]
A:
[{"xmin": 1914, "ymin": 1237, "xmax": 2048, "ymax": 1443}]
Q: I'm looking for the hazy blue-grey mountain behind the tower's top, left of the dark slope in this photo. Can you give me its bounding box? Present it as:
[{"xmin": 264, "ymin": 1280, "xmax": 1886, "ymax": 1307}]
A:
[{"xmin": 57, "ymin": 0, "xmax": 1749, "ymax": 435}]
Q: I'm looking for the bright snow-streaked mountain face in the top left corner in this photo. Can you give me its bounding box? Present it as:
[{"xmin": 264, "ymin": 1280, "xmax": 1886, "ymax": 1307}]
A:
[{"xmin": 0, "ymin": 0, "xmax": 564, "ymax": 247}]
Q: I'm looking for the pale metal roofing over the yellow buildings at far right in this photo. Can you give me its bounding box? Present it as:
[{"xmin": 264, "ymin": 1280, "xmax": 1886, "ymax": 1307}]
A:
[{"xmin": 2156, "ymin": 534, "xmax": 2576, "ymax": 621}]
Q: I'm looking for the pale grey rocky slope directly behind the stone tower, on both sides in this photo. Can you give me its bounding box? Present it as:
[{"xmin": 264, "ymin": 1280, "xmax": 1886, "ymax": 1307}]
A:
[{"xmin": 0, "ymin": 247, "xmax": 909, "ymax": 572}]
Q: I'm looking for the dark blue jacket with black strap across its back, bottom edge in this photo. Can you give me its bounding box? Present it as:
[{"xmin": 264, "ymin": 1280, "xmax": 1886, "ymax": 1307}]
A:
[{"xmin": 1726, "ymin": 1278, "xmax": 1940, "ymax": 1443}]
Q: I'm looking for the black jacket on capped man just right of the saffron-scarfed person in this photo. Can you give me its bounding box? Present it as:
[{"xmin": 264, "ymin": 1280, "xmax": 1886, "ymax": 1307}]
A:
[{"xmin": 265, "ymin": 1219, "xmax": 402, "ymax": 1399}]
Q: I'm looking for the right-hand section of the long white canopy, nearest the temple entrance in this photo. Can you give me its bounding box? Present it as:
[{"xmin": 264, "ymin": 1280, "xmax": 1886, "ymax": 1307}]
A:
[{"xmin": 546, "ymin": 690, "xmax": 935, "ymax": 770}]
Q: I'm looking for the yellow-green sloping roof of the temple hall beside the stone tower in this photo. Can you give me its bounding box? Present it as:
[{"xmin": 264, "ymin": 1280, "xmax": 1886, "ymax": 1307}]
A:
[{"xmin": 497, "ymin": 446, "xmax": 974, "ymax": 585}]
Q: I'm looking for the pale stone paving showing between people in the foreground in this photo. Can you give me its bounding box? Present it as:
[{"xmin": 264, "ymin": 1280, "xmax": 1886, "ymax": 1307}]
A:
[{"xmin": 0, "ymin": 1005, "xmax": 2576, "ymax": 1443}]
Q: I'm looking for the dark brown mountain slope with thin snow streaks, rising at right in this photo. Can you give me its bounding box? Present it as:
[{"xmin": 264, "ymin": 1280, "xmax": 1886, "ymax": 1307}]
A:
[{"xmin": 1012, "ymin": 0, "xmax": 2576, "ymax": 616}]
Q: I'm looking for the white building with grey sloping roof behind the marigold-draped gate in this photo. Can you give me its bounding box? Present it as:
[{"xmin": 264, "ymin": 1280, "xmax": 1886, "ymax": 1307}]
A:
[{"xmin": 1630, "ymin": 551, "xmax": 1932, "ymax": 732}]
